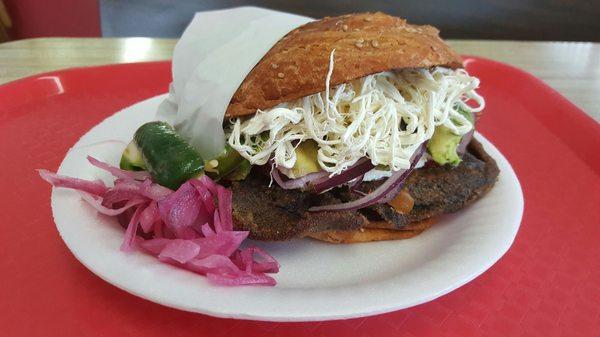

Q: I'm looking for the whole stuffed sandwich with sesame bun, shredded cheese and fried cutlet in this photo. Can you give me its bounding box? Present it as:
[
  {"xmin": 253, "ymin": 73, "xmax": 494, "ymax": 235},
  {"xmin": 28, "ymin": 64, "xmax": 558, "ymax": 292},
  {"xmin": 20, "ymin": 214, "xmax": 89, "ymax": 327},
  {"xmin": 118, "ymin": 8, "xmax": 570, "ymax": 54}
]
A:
[{"xmin": 225, "ymin": 13, "xmax": 499, "ymax": 243}]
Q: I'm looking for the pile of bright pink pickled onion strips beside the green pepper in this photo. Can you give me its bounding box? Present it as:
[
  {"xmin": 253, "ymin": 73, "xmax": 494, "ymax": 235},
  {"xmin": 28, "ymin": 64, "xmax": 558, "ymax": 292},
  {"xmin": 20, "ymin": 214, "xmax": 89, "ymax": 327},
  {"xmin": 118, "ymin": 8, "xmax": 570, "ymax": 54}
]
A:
[{"xmin": 38, "ymin": 157, "xmax": 279, "ymax": 286}]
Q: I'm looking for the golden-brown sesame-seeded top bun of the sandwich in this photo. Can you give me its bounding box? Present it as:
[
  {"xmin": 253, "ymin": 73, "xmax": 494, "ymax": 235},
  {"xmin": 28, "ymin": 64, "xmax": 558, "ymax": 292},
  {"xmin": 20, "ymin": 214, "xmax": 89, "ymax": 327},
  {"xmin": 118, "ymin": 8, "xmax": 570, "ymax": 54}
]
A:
[{"xmin": 225, "ymin": 12, "xmax": 462, "ymax": 117}]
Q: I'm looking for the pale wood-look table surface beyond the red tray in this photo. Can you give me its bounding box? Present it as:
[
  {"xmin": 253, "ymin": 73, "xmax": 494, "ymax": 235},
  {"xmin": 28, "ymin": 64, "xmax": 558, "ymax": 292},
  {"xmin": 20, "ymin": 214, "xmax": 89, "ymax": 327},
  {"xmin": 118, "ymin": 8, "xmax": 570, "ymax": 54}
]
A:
[{"xmin": 0, "ymin": 38, "xmax": 600, "ymax": 121}]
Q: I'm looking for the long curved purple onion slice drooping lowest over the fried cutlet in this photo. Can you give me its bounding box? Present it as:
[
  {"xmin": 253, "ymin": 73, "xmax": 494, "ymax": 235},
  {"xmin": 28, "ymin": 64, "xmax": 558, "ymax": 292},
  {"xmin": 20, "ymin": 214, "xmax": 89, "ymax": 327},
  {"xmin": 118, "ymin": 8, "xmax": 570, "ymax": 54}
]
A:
[{"xmin": 308, "ymin": 142, "xmax": 427, "ymax": 212}]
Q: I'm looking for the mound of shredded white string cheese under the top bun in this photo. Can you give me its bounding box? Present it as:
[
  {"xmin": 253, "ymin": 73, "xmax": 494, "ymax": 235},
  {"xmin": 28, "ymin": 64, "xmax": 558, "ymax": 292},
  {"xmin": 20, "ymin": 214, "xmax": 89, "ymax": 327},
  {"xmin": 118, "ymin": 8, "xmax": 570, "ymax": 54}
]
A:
[{"xmin": 226, "ymin": 53, "xmax": 485, "ymax": 174}]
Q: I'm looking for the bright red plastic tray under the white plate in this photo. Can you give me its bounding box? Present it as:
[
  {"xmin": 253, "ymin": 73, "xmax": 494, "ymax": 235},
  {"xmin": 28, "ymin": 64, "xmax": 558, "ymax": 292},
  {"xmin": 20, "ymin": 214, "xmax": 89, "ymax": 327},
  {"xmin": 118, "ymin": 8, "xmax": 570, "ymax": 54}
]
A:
[{"xmin": 0, "ymin": 57, "xmax": 600, "ymax": 336}]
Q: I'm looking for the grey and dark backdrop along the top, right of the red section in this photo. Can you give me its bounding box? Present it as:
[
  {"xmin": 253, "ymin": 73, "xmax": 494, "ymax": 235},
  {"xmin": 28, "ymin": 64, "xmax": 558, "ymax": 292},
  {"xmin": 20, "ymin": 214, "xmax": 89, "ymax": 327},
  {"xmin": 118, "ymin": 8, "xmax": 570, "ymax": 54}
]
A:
[{"xmin": 100, "ymin": 0, "xmax": 600, "ymax": 41}]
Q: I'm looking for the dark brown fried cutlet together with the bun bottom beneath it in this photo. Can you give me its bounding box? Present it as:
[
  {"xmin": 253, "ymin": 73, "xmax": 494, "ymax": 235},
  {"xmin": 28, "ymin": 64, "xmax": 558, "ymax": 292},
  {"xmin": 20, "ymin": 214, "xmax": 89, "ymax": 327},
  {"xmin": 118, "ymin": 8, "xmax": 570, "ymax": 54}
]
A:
[{"xmin": 232, "ymin": 140, "xmax": 499, "ymax": 243}]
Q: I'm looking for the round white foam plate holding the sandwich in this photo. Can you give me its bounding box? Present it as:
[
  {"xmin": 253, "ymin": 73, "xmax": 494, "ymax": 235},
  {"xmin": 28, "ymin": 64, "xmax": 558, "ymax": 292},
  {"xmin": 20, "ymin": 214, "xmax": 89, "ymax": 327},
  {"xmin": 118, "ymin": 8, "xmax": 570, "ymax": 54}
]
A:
[{"xmin": 52, "ymin": 96, "xmax": 523, "ymax": 321}]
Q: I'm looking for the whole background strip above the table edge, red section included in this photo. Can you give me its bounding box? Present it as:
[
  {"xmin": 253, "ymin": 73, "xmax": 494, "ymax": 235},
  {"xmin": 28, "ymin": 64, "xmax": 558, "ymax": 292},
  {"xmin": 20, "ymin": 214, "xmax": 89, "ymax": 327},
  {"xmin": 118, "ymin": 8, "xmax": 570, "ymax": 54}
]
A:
[{"xmin": 3, "ymin": 0, "xmax": 600, "ymax": 41}]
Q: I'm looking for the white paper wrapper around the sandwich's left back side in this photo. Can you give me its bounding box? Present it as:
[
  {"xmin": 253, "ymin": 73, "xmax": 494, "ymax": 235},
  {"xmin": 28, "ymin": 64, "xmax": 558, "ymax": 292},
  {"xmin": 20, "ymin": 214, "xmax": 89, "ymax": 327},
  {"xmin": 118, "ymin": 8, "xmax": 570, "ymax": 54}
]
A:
[{"xmin": 157, "ymin": 7, "xmax": 312, "ymax": 158}]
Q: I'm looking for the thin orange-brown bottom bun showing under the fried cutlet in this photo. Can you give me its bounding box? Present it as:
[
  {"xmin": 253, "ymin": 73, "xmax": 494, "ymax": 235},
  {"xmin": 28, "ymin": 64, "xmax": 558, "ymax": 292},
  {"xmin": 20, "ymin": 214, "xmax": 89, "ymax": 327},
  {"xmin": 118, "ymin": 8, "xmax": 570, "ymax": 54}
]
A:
[{"xmin": 307, "ymin": 218, "xmax": 435, "ymax": 243}]
